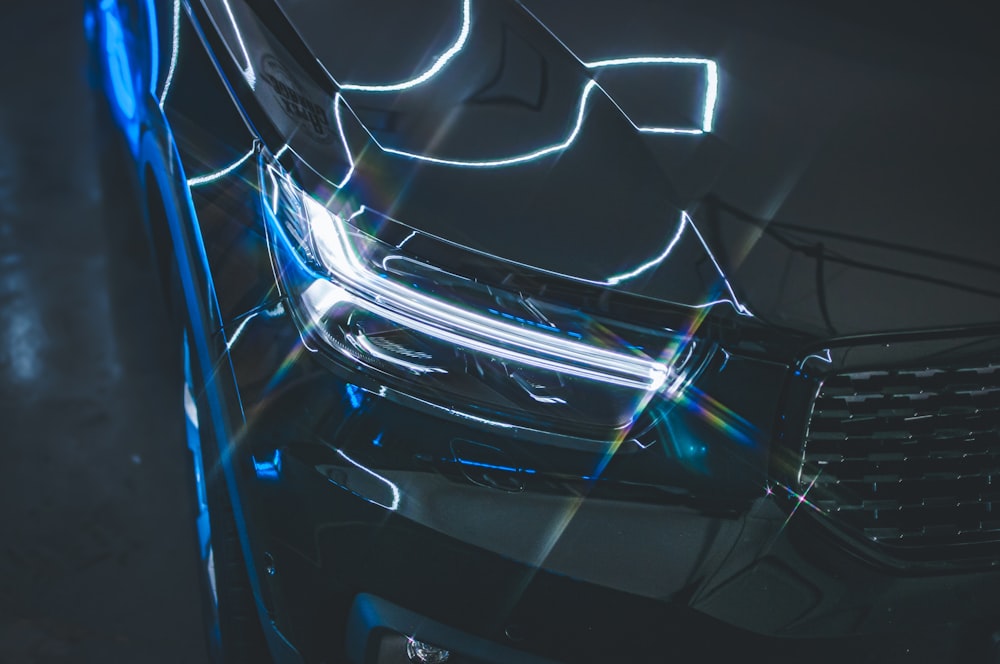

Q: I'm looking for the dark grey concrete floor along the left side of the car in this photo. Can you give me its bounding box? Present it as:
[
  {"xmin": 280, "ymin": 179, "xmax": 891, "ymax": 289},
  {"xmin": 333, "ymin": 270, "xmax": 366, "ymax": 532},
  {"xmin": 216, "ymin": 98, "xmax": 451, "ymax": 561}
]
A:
[{"xmin": 0, "ymin": 0, "xmax": 207, "ymax": 664}]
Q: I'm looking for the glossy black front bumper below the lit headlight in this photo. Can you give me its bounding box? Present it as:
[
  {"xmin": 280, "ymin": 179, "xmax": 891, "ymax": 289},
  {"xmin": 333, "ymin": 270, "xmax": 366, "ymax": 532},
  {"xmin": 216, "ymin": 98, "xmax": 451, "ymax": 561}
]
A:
[{"xmin": 215, "ymin": 308, "xmax": 1000, "ymax": 662}]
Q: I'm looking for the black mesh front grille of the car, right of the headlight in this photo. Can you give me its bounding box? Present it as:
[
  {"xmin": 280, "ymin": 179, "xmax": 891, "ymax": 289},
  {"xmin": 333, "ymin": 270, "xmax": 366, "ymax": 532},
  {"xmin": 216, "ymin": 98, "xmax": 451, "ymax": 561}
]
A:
[{"xmin": 800, "ymin": 363, "xmax": 1000, "ymax": 558}]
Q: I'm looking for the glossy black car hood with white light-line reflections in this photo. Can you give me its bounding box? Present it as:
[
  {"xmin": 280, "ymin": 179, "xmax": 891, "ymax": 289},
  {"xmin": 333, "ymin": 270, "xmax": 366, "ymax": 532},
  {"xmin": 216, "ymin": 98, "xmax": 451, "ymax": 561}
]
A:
[{"xmin": 262, "ymin": 0, "xmax": 1000, "ymax": 337}]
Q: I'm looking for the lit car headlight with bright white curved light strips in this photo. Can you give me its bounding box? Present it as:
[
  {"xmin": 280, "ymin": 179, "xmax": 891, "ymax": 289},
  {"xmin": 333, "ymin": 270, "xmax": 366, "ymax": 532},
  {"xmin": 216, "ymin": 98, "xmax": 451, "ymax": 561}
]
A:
[{"xmin": 260, "ymin": 158, "xmax": 708, "ymax": 441}]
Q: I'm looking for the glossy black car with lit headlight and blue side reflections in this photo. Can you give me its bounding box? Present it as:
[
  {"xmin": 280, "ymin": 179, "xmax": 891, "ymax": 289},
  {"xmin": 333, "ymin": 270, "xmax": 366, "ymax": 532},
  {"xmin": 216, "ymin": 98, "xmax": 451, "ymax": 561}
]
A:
[{"xmin": 86, "ymin": 0, "xmax": 1000, "ymax": 664}]
